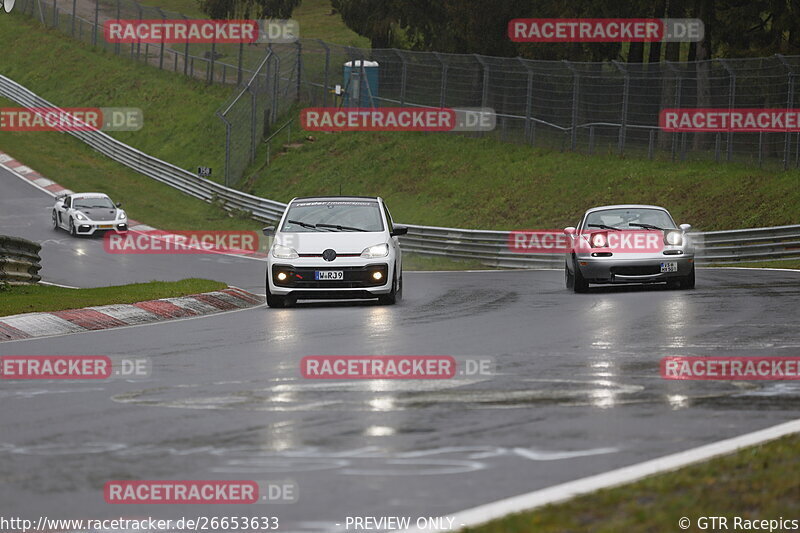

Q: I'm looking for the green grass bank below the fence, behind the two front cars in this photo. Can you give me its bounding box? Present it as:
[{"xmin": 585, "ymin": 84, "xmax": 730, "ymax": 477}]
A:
[{"xmin": 252, "ymin": 127, "xmax": 800, "ymax": 230}]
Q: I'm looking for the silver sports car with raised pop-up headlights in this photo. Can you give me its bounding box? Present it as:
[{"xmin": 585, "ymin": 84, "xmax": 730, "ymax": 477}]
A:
[{"xmin": 564, "ymin": 205, "xmax": 694, "ymax": 292}]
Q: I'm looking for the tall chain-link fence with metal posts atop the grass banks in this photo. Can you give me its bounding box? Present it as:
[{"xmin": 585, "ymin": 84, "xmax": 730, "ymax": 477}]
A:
[{"xmin": 10, "ymin": 0, "xmax": 800, "ymax": 183}]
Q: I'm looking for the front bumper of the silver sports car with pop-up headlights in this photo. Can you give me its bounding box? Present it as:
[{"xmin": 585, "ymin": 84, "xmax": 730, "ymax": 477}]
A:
[{"xmin": 576, "ymin": 254, "xmax": 694, "ymax": 283}]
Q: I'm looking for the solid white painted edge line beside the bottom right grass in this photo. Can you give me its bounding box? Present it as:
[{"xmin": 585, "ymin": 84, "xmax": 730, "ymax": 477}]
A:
[{"xmin": 394, "ymin": 419, "xmax": 800, "ymax": 533}]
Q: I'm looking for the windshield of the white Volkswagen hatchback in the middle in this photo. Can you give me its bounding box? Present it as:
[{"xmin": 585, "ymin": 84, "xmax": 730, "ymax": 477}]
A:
[{"xmin": 281, "ymin": 200, "xmax": 383, "ymax": 233}]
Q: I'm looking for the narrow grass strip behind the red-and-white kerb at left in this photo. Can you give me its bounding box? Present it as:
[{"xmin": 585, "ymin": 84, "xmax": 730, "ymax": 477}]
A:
[{"xmin": 0, "ymin": 278, "xmax": 227, "ymax": 316}]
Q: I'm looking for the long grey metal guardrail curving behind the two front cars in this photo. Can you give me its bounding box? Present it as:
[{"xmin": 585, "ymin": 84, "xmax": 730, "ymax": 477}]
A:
[{"xmin": 0, "ymin": 75, "xmax": 800, "ymax": 268}]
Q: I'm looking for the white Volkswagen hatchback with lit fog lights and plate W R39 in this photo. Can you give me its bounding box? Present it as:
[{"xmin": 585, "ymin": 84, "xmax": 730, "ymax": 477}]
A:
[{"xmin": 263, "ymin": 196, "xmax": 408, "ymax": 307}]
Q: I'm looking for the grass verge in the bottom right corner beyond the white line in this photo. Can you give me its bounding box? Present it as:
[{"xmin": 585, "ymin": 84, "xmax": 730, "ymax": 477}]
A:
[{"xmin": 463, "ymin": 435, "xmax": 800, "ymax": 533}]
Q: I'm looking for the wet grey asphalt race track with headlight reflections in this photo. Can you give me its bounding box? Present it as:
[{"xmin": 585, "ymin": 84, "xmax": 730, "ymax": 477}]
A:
[{"xmin": 0, "ymin": 164, "xmax": 800, "ymax": 532}]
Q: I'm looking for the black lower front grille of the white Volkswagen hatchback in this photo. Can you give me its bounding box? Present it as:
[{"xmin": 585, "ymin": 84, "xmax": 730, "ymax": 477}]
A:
[{"xmin": 272, "ymin": 263, "xmax": 389, "ymax": 289}]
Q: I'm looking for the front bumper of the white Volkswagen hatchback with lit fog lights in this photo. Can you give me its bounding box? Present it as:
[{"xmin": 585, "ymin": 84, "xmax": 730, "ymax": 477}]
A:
[{"xmin": 267, "ymin": 261, "xmax": 394, "ymax": 299}]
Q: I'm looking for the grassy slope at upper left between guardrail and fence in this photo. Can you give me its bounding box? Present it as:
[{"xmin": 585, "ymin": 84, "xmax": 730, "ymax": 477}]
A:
[{"xmin": 0, "ymin": 12, "xmax": 231, "ymax": 174}]
